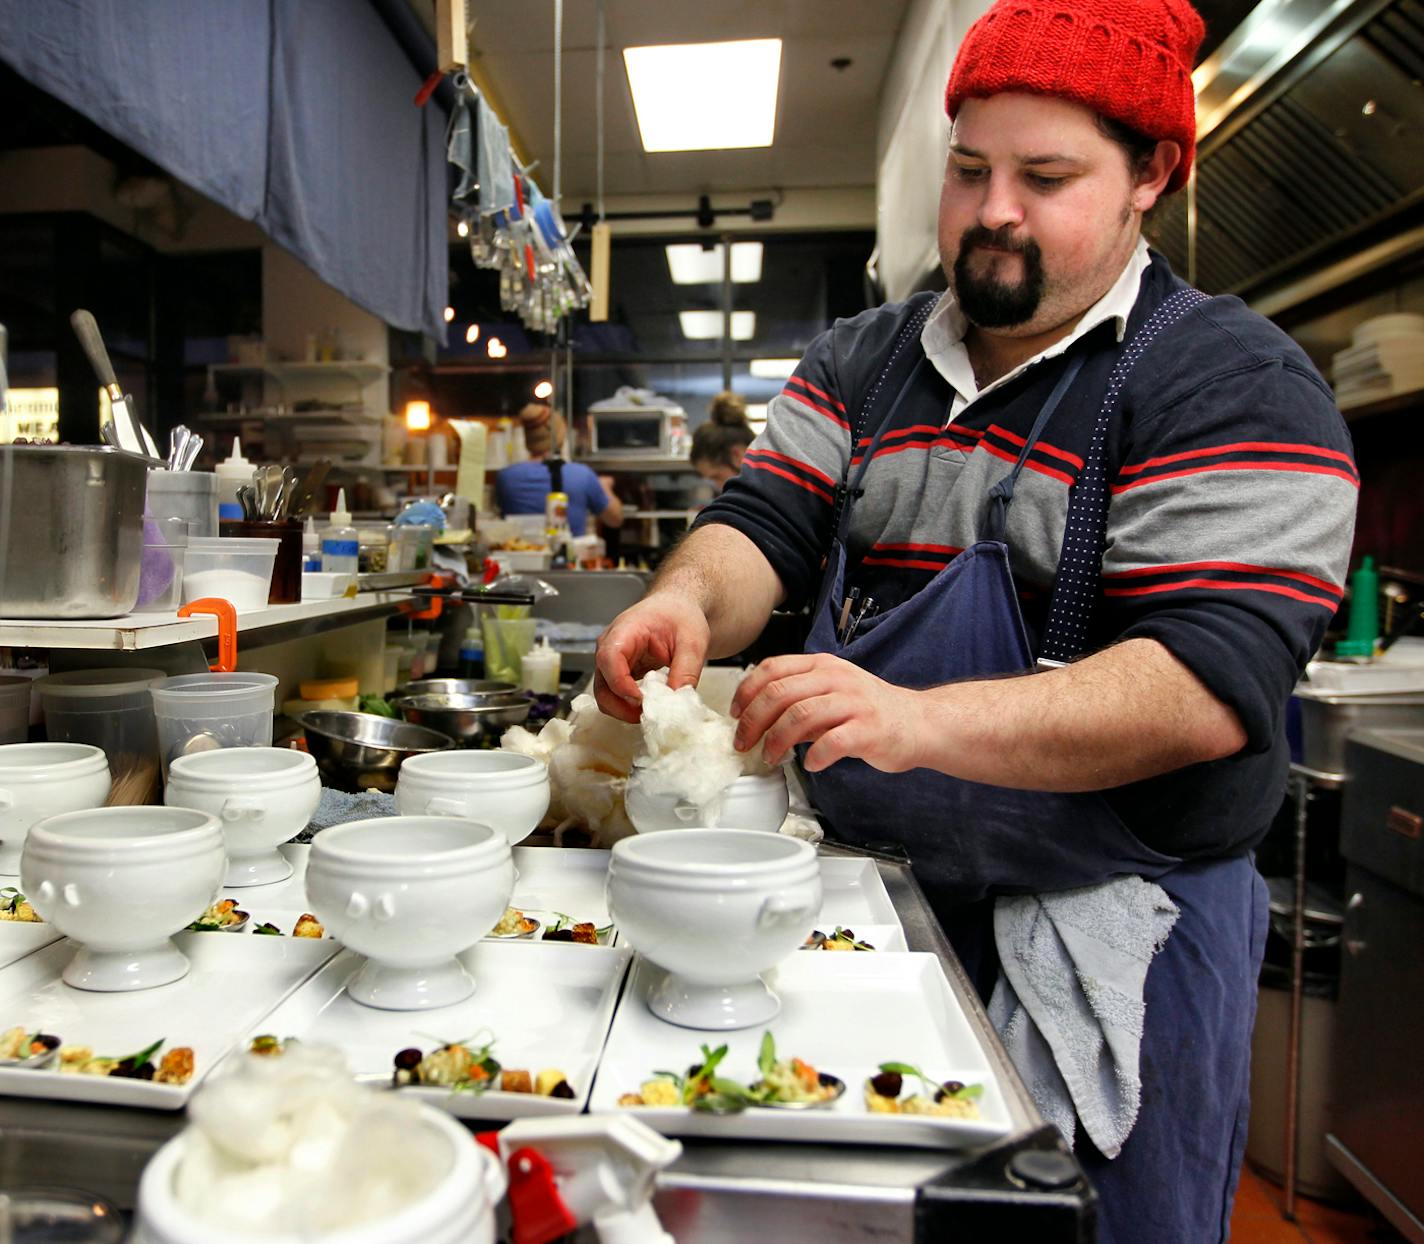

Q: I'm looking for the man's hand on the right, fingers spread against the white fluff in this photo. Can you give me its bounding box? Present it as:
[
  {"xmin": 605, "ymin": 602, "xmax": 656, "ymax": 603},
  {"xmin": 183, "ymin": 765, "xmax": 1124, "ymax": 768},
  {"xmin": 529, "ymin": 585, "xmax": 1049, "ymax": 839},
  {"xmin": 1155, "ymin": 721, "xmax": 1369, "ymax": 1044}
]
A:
[{"xmin": 732, "ymin": 653, "xmax": 923, "ymax": 773}]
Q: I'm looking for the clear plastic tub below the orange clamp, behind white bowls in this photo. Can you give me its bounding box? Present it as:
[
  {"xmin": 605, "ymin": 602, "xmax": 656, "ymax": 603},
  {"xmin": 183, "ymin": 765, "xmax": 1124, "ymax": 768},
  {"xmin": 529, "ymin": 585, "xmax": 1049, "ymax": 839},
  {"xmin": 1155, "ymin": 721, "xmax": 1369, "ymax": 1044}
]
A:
[{"xmin": 152, "ymin": 670, "xmax": 276, "ymax": 776}]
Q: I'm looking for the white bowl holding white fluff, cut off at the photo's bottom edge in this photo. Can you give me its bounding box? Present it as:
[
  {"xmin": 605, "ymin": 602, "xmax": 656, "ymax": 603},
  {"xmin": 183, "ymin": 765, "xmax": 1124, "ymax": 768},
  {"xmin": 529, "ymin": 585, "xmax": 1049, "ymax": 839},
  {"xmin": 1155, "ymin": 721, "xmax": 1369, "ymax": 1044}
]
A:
[{"xmin": 134, "ymin": 1102, "xmax": 506, "ymax": 1244}]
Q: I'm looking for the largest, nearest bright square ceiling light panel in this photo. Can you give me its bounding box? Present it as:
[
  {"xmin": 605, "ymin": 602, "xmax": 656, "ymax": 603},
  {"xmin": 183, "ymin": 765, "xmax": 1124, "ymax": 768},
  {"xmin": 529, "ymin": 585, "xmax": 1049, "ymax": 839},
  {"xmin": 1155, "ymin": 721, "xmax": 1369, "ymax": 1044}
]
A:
[{"xmin": 624, "ymin": 38, "xmax": 782, "ymax": 151}]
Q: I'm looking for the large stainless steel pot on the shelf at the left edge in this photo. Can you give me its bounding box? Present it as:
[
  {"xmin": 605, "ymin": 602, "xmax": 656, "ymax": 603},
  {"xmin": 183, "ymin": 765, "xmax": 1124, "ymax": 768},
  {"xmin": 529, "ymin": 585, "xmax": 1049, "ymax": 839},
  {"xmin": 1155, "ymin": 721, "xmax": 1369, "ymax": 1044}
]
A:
[{"xmin": 0, "ymin": 446, "xmax": 148, "ymax": 618}]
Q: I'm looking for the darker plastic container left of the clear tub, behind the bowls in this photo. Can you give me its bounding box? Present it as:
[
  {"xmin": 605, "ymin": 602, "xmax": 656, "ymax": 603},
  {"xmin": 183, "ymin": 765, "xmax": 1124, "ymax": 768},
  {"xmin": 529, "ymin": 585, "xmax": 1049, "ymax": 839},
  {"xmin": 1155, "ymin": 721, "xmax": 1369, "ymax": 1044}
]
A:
[{"xmin": 34, "ymin": 669, "xmax": 167, "ymax": 779}]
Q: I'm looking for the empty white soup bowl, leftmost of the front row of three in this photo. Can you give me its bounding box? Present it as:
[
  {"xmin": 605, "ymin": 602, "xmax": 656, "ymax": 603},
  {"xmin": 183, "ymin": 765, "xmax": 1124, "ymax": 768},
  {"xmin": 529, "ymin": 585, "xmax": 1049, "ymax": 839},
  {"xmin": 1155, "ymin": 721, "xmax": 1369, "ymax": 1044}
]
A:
[{"xmin": 20, "ymin": 807, "xmax": 228, "ymax": 992}]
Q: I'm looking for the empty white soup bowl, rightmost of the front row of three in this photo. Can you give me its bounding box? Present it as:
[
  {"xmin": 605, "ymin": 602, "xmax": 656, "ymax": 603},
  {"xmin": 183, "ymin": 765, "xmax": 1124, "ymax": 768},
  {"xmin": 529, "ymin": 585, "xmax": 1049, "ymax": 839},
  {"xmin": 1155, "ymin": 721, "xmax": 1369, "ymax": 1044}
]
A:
[{"xmin": 608, "ymin": 828, "xmax": 820, "ymax": 1029}]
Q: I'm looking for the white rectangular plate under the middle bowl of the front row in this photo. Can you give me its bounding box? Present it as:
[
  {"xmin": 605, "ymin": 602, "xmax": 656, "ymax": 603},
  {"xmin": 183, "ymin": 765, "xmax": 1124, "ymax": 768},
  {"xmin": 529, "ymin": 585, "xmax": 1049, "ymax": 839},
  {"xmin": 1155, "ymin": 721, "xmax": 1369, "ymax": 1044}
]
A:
[{"xmin": 244, "ymin": 942, "xmax": 632, "ymax": 1119}]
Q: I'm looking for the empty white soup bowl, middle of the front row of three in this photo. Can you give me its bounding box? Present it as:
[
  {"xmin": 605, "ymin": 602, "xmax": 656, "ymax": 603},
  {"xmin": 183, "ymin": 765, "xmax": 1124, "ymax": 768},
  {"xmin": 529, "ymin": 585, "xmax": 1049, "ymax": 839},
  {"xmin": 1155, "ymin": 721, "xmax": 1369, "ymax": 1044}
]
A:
[{"xmin": 306, "ymin": 817, "xmax": 514, "ymax": 1011}]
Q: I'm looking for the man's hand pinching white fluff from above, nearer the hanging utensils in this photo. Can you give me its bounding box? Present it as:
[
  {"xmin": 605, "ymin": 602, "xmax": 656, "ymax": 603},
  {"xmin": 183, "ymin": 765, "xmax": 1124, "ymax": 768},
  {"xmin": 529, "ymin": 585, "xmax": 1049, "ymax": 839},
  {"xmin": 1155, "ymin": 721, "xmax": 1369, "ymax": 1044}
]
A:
[{"xmin": 594, "ymin": 591, "xmax": 712, "ymax": 722}]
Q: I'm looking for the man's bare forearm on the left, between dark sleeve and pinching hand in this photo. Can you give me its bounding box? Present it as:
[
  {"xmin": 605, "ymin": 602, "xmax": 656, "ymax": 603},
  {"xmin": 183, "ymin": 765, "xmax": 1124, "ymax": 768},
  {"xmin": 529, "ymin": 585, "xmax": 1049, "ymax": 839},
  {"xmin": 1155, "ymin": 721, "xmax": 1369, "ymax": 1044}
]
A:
[{"xmin": 649, "ymin": 522, "xmax": 786, "ymax": 658}]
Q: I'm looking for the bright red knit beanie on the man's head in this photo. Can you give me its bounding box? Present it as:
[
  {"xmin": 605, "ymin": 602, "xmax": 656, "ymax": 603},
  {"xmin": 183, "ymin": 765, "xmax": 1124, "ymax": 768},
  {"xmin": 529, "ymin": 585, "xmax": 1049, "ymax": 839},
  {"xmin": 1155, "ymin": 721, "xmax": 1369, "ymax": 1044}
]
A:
[{"xmin": 944, "ymin": 0, "xmax": 1206, "ymax": 192}]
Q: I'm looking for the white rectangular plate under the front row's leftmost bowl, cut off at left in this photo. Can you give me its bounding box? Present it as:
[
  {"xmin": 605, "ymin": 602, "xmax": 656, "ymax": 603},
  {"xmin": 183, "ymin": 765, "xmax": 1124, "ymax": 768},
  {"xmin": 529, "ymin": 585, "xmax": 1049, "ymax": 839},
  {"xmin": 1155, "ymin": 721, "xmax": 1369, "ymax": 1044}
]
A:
[{"xmin": 0, "ymin": 934, "xmax": 339, "ymax": 1110}]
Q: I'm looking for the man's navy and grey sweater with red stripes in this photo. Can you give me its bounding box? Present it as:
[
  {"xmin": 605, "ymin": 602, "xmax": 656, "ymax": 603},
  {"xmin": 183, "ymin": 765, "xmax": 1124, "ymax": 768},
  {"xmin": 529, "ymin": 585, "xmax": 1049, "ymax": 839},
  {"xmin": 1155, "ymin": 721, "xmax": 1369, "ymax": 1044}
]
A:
[{"xmin": 699, "ymin": 255, "xmax": 1358, "ymax": 858}]
